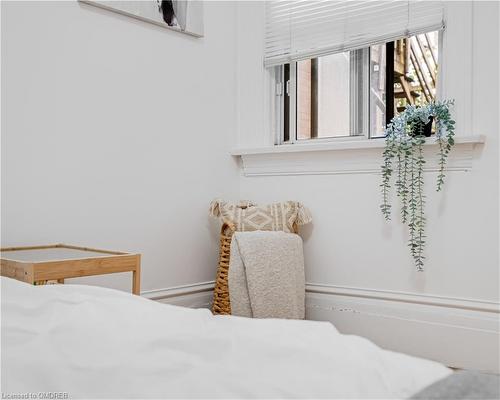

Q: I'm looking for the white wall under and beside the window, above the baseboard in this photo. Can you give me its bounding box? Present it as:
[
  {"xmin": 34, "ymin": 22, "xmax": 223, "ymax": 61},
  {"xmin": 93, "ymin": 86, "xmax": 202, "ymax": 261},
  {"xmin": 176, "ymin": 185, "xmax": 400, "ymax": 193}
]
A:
[{"xmin": 238, "ymin": 2, "xmax": 499, "ymax": 301}]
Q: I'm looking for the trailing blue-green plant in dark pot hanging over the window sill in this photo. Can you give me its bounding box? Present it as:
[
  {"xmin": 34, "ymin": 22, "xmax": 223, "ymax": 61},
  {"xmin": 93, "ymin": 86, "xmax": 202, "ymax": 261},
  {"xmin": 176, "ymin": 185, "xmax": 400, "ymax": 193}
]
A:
[{"xmin": 380, "ymin": 100, "xmax": 455, "ymax": 271}]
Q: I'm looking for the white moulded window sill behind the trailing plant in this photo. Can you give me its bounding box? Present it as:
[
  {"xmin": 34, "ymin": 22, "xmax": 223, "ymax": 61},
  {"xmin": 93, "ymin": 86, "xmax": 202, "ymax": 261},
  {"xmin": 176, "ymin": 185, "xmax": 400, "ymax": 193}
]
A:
[{"xmin": 231, "ymin": 135, "xmax": 485, "ymax": 176}]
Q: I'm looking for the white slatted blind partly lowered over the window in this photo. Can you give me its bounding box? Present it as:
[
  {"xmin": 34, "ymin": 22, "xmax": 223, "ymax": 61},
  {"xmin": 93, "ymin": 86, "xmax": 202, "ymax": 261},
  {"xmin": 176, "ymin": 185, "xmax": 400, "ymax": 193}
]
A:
[{"xmin": 264, "ymin": 0, "xmax": 444, "ymax": 66}]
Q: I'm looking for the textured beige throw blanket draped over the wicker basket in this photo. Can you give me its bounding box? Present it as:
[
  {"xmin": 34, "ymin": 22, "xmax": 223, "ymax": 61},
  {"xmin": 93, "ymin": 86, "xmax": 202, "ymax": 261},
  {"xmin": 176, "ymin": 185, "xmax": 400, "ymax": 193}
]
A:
[{"xmin": 228, "ymin": 231, "xmax": 305, "ymax": 319}]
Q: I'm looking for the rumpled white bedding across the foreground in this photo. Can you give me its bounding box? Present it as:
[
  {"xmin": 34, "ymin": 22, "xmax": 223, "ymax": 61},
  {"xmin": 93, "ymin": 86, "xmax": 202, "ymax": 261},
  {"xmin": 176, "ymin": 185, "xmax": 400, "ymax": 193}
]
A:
[{"xmin": 1, "ymin": 278, "xmax": 451, "ymax": 399}]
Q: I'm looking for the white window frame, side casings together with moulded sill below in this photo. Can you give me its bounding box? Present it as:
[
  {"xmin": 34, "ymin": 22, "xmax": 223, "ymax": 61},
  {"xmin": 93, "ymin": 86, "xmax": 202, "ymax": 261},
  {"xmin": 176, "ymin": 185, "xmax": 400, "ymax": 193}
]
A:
[{"xmin": 230, "ymin": 2, "xmax": 486, "ymax": 177}]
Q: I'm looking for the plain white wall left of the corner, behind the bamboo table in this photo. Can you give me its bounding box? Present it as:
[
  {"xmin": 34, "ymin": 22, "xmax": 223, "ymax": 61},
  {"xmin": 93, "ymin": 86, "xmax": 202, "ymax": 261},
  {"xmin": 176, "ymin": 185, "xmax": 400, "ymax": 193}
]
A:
[{"xmin": 1, "ymin": 1, "xmax": 238, "ymax": 290}]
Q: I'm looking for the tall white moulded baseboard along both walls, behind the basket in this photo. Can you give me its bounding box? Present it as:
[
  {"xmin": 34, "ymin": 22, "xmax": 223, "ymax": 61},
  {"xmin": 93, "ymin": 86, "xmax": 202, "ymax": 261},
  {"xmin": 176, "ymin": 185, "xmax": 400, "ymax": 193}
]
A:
[{"xmin": 142, "ymin": 282, "xmax": 500, "ymax": 373}]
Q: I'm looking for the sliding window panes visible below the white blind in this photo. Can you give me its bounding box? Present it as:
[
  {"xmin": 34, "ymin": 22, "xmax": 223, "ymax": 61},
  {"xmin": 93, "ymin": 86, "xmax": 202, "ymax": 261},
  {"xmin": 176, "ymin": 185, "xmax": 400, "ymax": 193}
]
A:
[{"xmin": 274, "ymin": 31, "xmax": 439, "ymax": 143}]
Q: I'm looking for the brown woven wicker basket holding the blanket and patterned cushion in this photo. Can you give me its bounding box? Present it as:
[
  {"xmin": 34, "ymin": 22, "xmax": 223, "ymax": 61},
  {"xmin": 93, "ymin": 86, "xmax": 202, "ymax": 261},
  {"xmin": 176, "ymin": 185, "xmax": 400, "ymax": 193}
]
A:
[{"xmin": 212, "ymin": 223, "xmax": 298, "ymax": 315}]
